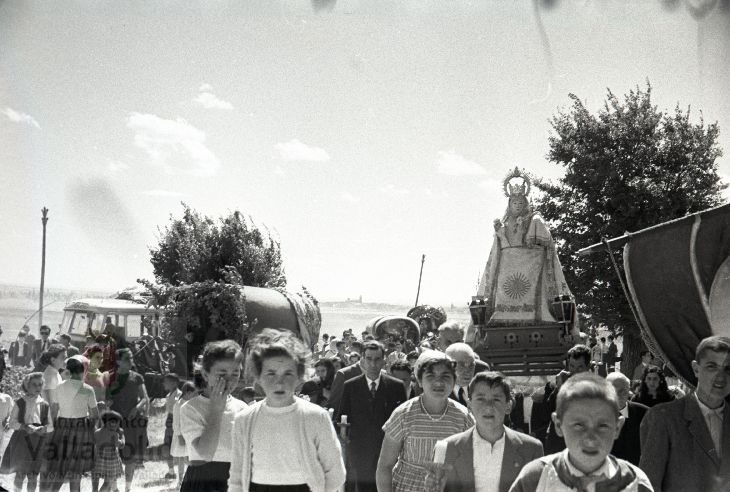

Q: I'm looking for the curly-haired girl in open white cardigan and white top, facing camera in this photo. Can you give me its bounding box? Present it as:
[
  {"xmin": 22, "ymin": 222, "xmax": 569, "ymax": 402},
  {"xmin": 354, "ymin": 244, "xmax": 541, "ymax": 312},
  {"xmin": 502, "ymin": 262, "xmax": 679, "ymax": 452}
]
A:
[{"xmin": 228, "ymin": 329, "xmax": 345, "ymax": 492}]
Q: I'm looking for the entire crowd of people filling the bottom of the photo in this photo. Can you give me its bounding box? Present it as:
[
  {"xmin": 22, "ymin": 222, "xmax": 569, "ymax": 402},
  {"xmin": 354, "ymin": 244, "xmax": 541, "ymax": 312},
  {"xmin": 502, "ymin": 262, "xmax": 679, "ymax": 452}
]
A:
[{"xmin": 0, "ymin": 321, "xmax": 730, "ymax": 492}]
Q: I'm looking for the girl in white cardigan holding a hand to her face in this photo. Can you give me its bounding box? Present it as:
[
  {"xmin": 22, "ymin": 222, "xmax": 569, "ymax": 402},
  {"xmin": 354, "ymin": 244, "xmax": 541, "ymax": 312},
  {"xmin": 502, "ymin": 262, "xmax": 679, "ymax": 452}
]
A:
[{"xmin": 180, "ymin": 340, "xmax": 247, "ymax": 492}]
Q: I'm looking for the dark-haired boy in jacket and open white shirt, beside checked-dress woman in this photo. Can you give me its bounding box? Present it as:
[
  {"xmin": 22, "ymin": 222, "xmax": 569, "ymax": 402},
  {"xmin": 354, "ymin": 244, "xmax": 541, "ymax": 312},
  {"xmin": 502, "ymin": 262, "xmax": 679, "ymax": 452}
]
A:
[{"xmin": 426, "ymin": 372, "xmax": 543, "ymax": 492}]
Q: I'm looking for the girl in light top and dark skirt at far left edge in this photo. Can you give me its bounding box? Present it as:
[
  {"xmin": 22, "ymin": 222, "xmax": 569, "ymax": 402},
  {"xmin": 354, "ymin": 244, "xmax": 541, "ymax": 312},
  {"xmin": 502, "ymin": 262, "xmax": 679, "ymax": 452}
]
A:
[{"xmin": 0, "ymin": 372, "xmax": 53, "ymax": 491}]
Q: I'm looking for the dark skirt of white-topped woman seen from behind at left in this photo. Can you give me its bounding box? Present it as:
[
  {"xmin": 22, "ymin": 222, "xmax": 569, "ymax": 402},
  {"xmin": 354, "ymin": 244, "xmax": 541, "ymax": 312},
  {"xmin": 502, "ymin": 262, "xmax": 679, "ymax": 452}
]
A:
[{"xmin": 41, "ymin": 417, "xmax": 94, "ymax": 480}]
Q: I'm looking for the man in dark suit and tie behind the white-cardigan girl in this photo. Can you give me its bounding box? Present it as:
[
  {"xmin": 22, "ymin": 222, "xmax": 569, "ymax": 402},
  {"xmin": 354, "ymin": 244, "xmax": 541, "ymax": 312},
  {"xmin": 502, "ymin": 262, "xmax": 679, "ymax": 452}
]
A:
[{"xmin": 337, "ymin": 341, "xmax": 406, "ymax": 492}]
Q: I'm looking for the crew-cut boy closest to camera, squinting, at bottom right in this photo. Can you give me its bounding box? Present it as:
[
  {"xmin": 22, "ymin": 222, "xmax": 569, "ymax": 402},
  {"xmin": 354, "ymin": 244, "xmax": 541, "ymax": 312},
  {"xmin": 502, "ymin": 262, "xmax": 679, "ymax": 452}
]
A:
[{"xmin": 510, "ymin": 373, "xmax": 653, "ymax": 492}]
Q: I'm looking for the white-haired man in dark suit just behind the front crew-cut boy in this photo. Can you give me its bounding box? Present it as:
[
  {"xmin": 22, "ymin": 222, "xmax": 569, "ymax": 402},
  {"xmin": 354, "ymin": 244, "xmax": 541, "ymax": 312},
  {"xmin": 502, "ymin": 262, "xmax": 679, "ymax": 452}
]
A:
[{"xmin": 606, "ymin": 372, "xmax": 649, "ymax": 466}]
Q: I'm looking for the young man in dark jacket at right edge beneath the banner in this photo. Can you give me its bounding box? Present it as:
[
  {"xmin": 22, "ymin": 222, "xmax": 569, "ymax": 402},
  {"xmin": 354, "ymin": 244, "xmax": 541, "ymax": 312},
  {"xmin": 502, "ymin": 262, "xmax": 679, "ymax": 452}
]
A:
[{"xmin": 639, "ymin": 336, "xmax": 730, "ymax": 492}]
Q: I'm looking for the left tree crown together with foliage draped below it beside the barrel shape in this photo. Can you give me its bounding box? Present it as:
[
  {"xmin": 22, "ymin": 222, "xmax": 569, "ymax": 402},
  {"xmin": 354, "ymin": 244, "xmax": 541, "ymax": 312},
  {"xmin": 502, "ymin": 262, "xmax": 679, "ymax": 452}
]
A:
[{"xmin": 144, "ymin": 203, "xmax": 286, "ymax": 357}]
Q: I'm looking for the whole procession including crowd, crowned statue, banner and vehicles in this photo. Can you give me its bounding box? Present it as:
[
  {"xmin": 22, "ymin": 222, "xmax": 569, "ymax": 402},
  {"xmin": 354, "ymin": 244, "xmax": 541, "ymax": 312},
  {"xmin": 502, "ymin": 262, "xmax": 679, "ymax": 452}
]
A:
[{"xmin": 0, "ymin": 168, "xmax": 730, "ymax": 492}]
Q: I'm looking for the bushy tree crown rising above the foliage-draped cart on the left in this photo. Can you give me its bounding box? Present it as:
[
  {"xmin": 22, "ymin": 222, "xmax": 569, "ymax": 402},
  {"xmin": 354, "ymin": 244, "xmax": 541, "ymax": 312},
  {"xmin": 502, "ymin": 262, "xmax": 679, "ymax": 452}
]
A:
[{"xmin": 150, "ymin": 203, "xmax": 286, "ymax": 287}]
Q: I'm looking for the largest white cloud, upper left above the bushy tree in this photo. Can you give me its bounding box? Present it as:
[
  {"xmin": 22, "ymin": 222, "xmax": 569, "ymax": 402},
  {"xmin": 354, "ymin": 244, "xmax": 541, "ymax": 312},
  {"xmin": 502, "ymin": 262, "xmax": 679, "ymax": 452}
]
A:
[{"xmin": 127, "ymin": 113, "xmax": 220, "ymax": 176}]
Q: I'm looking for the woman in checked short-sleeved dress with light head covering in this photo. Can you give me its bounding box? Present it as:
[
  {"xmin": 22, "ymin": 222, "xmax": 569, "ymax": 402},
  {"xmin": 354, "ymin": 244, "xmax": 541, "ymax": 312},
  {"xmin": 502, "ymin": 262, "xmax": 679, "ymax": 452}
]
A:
[{"xmin": 376, "ymin": 350, "xmax": 474, "ymax": 492}]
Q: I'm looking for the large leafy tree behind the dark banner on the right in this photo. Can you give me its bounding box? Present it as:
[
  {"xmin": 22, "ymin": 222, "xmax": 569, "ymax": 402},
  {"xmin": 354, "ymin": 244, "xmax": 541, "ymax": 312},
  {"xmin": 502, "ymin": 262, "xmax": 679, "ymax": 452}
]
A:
[{"xmin": 536, "ymin": 83, "xmax": 726, "ymax": 377}]
